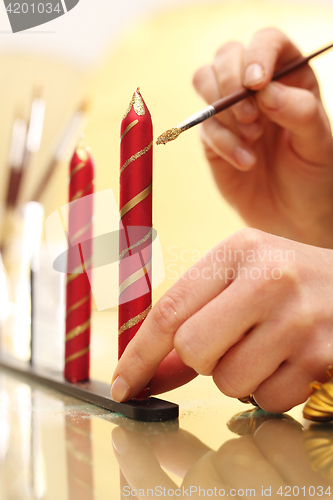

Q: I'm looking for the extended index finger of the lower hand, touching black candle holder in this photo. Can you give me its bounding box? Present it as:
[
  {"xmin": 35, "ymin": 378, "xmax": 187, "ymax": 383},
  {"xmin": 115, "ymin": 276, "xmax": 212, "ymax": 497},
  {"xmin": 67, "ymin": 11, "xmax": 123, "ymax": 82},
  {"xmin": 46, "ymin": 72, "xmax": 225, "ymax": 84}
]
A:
[{"xmin": 111, "ymin": 238, "xmax": 241, "ymax": 402}]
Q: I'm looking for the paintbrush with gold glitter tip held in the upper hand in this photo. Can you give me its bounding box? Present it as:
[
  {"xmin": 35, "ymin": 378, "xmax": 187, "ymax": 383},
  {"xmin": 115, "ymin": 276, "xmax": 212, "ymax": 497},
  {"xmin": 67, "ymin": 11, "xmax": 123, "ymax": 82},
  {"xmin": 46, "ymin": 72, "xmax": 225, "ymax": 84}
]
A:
[{"xmin": 156, "ymin": 43, "xmax": 333, "ymax": 144}]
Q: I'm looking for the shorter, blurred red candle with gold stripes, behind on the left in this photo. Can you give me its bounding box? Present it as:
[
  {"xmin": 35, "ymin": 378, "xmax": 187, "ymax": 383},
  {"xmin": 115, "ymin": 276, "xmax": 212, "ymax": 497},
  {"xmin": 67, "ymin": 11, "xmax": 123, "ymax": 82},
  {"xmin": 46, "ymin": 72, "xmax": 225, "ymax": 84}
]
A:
[{"xmin": 65, "ymin": 146, "xmax": 94, "ymax": 383}]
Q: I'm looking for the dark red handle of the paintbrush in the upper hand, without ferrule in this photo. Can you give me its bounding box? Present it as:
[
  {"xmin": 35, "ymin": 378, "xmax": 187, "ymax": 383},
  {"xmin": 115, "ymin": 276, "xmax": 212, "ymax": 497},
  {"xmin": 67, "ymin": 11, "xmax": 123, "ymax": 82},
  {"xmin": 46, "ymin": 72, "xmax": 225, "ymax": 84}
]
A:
[{"xmin": 211, "ymin": 43, "xmax": 333, "ymax": 113}]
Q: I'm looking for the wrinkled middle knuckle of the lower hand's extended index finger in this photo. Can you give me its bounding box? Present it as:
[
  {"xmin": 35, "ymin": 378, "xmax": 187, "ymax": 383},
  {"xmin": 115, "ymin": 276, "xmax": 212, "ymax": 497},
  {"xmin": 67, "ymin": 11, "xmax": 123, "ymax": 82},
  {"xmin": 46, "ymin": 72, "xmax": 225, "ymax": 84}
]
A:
[{"xmin": 151, "ymin": 292, "xmax": 184, "ymax": 334}]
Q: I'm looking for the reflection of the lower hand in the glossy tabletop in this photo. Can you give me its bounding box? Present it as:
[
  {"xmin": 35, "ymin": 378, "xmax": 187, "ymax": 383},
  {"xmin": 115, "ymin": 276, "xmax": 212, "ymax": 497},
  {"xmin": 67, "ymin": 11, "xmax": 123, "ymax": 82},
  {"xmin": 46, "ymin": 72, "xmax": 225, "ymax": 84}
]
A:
[{"xmin": 112, "ymin": 412, "xmax": 331, "ymax": 500}]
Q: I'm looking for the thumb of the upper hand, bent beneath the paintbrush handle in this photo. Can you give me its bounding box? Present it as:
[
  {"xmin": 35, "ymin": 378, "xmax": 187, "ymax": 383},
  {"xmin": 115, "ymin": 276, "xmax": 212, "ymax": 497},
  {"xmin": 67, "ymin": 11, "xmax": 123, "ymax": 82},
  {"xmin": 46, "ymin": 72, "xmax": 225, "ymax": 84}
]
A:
[{"xmin": 256, "ymin": 82, "xmax": 333, "ymax": 165}]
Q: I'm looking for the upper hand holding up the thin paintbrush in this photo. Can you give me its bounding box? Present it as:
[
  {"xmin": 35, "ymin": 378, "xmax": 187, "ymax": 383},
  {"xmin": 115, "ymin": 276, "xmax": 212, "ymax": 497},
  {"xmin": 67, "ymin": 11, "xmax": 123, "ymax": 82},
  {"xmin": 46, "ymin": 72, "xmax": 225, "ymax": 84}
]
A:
[{"xmin": 194, "ymin": 28, "xmax": 333, "ymax": 248}]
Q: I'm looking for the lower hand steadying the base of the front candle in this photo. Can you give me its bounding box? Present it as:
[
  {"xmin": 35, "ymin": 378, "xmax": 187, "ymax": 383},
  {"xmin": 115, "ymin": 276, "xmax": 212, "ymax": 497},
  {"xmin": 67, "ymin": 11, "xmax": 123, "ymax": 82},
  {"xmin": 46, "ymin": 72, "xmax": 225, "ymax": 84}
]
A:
[{"xmin": 112, "ymin": 229, "xmax": 333, "ymax": 412}]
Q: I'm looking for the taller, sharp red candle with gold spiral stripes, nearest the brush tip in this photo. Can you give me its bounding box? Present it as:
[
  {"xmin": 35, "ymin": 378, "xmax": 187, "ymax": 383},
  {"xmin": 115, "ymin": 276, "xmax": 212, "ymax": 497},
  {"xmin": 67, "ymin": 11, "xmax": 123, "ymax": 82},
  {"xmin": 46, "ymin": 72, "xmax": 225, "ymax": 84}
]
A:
[{"xmin": 118, "ymin": 89, "xmax": 153, "ymax": 399}]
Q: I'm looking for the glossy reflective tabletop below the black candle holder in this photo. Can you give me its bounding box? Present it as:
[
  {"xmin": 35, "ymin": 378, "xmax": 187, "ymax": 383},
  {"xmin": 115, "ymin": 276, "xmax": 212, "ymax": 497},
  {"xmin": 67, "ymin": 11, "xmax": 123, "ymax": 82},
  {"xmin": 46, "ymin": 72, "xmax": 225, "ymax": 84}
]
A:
[{"xmin": 0, "ymin": 356, "xmax": 333, "ymax": 500}]
